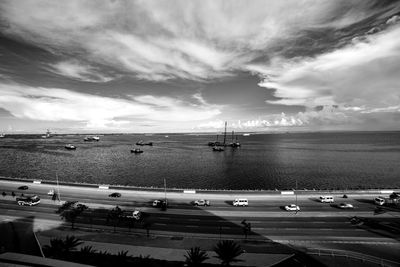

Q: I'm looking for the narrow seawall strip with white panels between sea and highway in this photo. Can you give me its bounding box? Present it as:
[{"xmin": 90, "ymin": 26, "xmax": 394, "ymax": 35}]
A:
[{"xmin": 0, "ymin": 176, "xmax": 400, "ymax": 195}]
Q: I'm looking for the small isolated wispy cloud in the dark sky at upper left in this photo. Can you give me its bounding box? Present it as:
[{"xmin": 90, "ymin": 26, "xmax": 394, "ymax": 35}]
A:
[{"xmin": 49, "ymin": 60, "xmax": 113, "ymax": 83}]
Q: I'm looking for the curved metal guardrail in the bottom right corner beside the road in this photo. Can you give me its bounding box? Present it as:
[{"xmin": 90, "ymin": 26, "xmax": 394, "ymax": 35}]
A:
[{"xmin": 305, "ymin": 248, "xmax": 400, "ymax": 267}]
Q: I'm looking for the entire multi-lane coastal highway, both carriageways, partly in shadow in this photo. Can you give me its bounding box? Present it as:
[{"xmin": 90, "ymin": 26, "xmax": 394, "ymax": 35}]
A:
[{"xmin": 0, "ymin": 181, "xmax": 400, "ymax": 259}]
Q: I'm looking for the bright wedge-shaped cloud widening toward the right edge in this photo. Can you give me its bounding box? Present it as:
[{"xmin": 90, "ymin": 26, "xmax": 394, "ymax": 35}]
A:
[{"xmin": 255, "ymin": 24, "xmax": 400, "ymax": 109}]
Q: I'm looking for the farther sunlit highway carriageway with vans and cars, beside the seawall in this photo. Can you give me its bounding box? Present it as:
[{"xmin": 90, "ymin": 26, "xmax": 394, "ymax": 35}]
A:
[{"xmin": 0, "ymin": 181, "xmax": 382, "ymax": 212}]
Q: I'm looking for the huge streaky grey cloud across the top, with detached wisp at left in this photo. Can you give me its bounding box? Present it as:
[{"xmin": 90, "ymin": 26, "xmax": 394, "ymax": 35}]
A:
[{"xmin": 0, "ymin": 0, "xmax": 390, "ymax": 82}]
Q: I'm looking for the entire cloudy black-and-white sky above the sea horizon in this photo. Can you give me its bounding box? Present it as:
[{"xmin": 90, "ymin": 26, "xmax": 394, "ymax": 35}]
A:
[{"xmin": 0, "ymin": 0, "xmax": 400, "ymax": 134}]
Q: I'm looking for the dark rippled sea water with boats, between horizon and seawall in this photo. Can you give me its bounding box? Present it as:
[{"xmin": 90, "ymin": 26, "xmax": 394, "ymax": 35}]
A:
[{"xmin": 0, "ymin": 132, "xmax": 400, "ymax": 190}]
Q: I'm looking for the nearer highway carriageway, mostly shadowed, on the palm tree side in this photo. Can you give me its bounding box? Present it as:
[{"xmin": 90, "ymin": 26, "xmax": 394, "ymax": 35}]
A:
[{"xmin": 0, "ymin": 200, "xmax": 396, "ymax": 243}]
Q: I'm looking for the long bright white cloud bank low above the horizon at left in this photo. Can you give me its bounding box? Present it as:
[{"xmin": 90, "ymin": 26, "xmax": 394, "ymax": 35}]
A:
[{"xmin": 0, "ymin": 84, "xmax": 220, "ymax": 129}]
